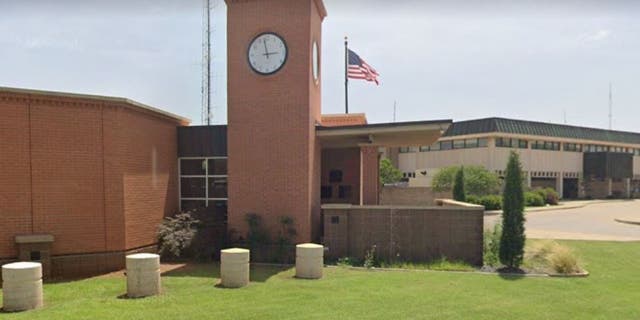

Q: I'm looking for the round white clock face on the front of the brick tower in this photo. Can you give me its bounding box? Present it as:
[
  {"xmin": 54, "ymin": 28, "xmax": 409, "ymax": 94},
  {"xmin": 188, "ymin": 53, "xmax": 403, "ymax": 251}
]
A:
[{"xmin": 247, "ymin": 32, "xmax": 287, "ymax": 75}]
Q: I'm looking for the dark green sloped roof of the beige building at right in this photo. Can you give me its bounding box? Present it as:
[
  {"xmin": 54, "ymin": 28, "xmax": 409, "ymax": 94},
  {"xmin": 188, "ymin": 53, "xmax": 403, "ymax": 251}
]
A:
[{"xmin": 444, "ymin": 118, "xmax": 640, "ymax": 144}]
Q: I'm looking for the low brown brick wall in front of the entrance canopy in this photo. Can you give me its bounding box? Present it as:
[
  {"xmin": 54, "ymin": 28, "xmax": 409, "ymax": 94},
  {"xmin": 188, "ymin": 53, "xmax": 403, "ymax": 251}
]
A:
[{"xmin": 323, "ymin": 205, "xmax": 484, "ymax": 265}]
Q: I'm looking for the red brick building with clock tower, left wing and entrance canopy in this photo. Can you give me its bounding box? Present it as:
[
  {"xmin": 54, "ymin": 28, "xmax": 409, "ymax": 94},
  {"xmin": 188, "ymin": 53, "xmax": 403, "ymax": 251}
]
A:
[{"xmin": 0, "ymin": 0, "xmax": 451, "ymax": 275}]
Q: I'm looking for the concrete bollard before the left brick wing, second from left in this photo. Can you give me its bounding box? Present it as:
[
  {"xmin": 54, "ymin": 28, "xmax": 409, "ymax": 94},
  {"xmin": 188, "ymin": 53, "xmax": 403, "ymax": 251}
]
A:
[{"xmin": 126, "ymin": 253, "xmax": 161, "ymax": 298}]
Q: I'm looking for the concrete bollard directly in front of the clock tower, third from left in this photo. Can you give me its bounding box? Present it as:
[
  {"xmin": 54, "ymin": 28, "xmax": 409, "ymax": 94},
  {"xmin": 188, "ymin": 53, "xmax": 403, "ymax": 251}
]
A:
[{"xmin": 220, "ymin": 248, "xmax": 249, "ymax": 288}]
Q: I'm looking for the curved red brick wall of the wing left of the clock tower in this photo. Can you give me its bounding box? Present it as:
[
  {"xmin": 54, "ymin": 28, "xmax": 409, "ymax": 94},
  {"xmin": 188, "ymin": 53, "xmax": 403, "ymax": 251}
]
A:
[{"xmin": 0, "ymin": 91, "xmax": 184, "ymax": 272}]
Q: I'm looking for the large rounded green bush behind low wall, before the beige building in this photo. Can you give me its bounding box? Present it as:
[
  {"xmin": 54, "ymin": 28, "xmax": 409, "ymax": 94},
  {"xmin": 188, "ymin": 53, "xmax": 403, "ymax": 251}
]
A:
[{"xmin": 431, "ymin": 166, "xmax": 501, "ymax": 197}]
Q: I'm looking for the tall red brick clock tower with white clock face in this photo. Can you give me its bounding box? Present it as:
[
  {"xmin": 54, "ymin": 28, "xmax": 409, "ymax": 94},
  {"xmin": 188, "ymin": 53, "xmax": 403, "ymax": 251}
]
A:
[{"xmin": 226, "ymin": 0, "xmax": 326, "ymax": 242}]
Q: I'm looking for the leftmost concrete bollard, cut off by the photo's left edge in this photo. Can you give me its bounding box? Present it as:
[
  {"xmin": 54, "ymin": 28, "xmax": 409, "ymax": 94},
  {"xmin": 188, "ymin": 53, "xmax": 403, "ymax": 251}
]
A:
[{"xmin": 2, "ymin": 262, "xmax": 43, "ymax": 312}]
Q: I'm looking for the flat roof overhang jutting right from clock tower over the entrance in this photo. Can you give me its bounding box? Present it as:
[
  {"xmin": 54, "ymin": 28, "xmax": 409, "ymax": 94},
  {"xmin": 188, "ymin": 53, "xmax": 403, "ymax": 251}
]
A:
[{"xmin": 316, "ymin": 120, "xmax": 452, "ymax": 148}]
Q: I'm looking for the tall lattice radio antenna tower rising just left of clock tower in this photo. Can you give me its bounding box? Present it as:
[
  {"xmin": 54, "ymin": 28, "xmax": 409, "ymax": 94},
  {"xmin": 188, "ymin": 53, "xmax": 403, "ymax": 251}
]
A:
[{"xmin": 202, "ymin": 0, "xmax": 212, "ymax": 125}]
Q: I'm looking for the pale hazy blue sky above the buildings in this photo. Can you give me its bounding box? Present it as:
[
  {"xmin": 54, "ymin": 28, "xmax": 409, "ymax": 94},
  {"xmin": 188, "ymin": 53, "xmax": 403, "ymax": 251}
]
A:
[{"xmin": 0, "ymin": 0, "xmax": 640, "ymax": 131}]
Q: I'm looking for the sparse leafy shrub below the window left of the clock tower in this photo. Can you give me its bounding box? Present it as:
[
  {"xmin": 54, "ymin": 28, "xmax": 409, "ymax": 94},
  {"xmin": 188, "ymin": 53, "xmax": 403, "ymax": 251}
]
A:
[{"xmin": 158, "ymin": 212, "xmax": 200, "ymax": 259}]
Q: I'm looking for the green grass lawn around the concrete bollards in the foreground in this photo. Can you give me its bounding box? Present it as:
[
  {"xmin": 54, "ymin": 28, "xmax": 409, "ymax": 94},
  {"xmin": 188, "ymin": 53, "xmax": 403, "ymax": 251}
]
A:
[{"xmin": 0, "ymin": 241, "xmax": 640, "ymax": 320}]
